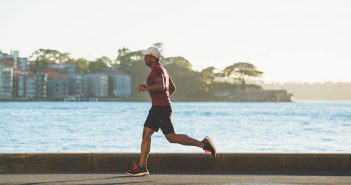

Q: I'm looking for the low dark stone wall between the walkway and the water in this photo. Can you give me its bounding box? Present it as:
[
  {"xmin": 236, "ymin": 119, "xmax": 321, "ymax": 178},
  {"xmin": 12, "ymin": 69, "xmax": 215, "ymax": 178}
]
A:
[{"xmin": 0, "ymin": 153, "xmax": 351, "ymax": 175}]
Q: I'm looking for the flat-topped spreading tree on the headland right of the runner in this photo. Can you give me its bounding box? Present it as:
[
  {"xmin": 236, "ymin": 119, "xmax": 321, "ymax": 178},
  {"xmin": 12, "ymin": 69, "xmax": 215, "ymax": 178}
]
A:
[{"xmin": 223, "ymin": 62, "xmax": 263, "ymax": 84}]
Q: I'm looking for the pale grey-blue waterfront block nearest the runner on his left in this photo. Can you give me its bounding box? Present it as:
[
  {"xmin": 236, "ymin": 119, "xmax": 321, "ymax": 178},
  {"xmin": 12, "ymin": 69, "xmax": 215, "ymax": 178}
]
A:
[{"xmin": 110, "ymin": 75, "xmax": 132, "ymax": 97}]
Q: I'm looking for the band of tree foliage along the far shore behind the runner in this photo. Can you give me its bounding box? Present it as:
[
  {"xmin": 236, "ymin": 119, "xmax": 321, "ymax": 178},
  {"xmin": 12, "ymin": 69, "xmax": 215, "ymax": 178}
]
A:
[{"xmin": 30, "ymin": 47, "xmax": 263, "ymax": 100}]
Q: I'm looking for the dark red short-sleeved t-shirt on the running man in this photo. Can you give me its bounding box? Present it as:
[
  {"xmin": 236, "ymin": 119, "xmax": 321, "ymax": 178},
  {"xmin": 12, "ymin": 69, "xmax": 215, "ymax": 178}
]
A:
[{"xmin": 146, "ymin": 63, "xmax": 171, "ymax": 106}]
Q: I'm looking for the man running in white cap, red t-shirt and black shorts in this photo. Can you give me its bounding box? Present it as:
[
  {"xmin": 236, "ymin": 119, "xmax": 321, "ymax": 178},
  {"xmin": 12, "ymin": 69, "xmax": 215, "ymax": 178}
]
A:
[{"xmin": 126, "ymin": 47, "xmax": 216, "ymax": 176}]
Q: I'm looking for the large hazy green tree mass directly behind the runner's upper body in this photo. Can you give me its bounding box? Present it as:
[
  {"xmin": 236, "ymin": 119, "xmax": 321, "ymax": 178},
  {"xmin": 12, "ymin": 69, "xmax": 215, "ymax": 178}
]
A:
[{"xmin": 116, "ymin": 48, "xmax": 209, "ymax": 99}]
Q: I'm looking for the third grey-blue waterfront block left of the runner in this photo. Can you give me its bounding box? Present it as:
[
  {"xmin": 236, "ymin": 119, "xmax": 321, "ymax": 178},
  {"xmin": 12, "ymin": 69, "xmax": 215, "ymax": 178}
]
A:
[{"xmin": 68, "ymin": 74, "xmax": 88, "ymax": 97}]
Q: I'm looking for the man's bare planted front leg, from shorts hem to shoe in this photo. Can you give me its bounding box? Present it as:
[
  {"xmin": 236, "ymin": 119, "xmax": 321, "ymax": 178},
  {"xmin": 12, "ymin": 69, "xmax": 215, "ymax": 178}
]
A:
[{"xmin": 139, "ymin": 127, "xmax": 154, "ymax": 166}]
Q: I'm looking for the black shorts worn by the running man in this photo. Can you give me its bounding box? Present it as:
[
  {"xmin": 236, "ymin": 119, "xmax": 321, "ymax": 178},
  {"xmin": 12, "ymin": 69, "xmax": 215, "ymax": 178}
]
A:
[{"xmin": 144, "ymin": 105, "xmax": 174, "ymax": 135}]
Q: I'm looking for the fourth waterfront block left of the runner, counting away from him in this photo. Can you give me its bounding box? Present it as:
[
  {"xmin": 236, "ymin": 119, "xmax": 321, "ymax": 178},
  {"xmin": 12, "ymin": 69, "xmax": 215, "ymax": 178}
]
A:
[{"xmin": 46, "ymin": 72, "xmax": 69, "ymax": 98}]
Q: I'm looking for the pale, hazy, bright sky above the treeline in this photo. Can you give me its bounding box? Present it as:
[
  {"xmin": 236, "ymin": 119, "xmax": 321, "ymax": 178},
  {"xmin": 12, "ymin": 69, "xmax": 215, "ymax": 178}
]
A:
[{"xmin": 0, "ymin": 0, "xmax": 351, "ymax": 82}]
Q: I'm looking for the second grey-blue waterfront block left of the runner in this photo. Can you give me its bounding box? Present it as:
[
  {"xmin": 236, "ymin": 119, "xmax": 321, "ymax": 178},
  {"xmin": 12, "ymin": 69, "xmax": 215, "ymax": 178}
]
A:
[{"xmin": 88, "ymin": 73, "xmax": 108, "ymax": 97}]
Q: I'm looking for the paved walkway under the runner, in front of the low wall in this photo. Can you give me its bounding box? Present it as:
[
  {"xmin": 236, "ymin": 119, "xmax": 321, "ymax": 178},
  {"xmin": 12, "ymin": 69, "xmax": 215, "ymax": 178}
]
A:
[{"xmin": 0, "ymin": 174, "xmax": 351, "ymax": 185}]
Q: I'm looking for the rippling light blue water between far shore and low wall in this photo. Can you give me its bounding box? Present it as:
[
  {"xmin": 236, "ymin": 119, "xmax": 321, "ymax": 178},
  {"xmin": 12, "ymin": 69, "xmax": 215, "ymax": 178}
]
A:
[{"xmin": 0, "ymin": 102, "xmax": 351, "ymax": 153}]
